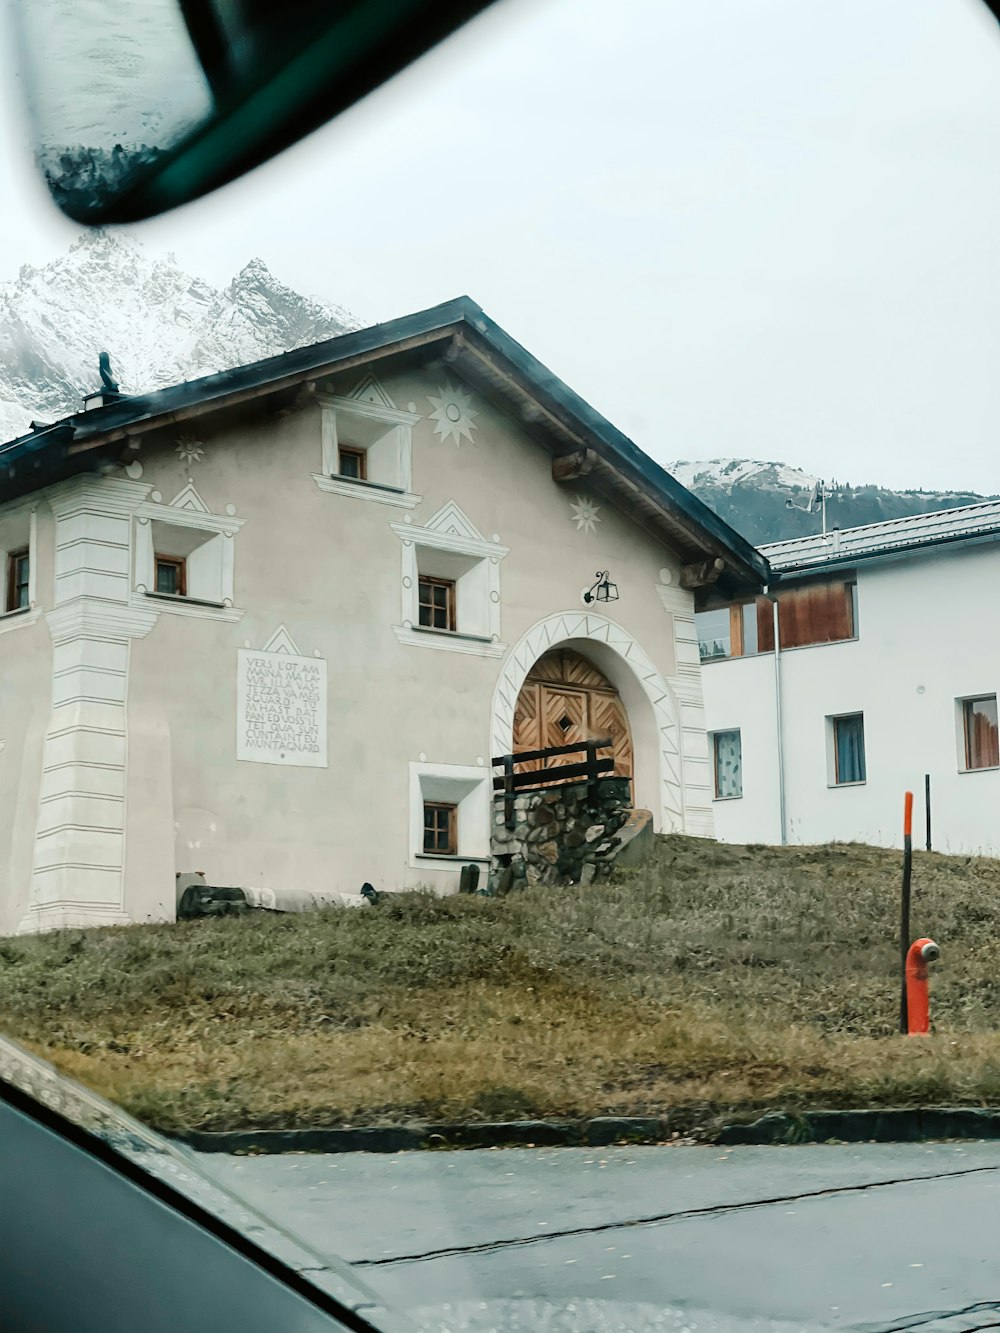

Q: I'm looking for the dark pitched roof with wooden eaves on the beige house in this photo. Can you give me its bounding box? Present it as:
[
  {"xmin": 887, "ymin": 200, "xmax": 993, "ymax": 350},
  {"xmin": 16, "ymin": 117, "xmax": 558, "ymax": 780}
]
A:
[{"xmin": 0, "ymin": 305, "xmax": 769, "ymax": 592}]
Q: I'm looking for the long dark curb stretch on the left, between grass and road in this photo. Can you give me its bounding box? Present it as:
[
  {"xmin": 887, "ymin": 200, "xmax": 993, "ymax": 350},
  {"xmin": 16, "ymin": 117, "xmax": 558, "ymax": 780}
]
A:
[{"xmin": 171, "ymin": 1116, "xmax": 669, "ymax": 1154}]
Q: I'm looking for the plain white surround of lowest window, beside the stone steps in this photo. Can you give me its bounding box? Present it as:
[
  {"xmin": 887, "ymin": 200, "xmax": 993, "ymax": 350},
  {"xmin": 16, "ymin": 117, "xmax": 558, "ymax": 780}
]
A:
[{"xmin": 409, "ymin": 762, "xmax": 492, "ymax": 870}]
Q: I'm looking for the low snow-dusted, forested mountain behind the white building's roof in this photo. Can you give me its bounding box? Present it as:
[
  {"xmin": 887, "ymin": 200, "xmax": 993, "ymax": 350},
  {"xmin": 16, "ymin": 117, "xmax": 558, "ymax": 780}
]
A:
[{"xmin": 667, "ymin": 459, "xmax": 997, "ymax": 545}]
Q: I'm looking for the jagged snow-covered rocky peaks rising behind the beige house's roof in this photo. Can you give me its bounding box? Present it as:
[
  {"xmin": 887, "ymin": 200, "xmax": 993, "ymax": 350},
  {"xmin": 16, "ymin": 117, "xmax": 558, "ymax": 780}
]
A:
[{"xmin": 0, "ymin": 232, "xmax": 359, "ymax": 440}]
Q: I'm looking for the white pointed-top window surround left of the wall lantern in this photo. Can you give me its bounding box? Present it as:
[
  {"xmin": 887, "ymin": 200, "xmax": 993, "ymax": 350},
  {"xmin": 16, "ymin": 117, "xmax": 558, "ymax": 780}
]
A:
[{"xmin": 391, "ymin": 500, "xmax": 511, "ymax": 657}]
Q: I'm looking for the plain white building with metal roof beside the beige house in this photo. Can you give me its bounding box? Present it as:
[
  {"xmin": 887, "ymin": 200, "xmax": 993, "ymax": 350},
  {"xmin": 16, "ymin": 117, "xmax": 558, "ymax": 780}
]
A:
[{"xmin": 696, "ymin": 501, "xmax": 1000, "ymax": 854}]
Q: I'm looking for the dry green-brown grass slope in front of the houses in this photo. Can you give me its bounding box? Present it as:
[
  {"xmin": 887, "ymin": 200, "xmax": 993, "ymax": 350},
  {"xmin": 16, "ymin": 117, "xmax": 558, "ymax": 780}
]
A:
[{"xmin": 0, "ymin": 838, "xmax": 1000, "ymax": 1129}]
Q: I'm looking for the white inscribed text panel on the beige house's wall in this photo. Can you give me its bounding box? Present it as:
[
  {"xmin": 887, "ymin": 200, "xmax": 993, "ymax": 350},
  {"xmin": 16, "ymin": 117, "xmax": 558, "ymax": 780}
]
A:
[{"xmin": 236, "ymin": 648, "xmax": 327, "ymax": 768}]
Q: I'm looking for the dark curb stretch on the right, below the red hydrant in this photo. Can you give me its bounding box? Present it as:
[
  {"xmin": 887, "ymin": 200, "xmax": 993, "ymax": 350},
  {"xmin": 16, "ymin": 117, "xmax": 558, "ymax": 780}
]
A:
[{"xmin": 713, "ymin": 1106, "xmax": 1000, "ymax": 1144}]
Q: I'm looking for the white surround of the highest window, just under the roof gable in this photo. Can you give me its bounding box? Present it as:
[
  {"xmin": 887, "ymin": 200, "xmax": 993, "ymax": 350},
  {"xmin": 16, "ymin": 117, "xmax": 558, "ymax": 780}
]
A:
[{"xmin": 312, "ymin": 393, "xmax": 420, "ymax": 509}]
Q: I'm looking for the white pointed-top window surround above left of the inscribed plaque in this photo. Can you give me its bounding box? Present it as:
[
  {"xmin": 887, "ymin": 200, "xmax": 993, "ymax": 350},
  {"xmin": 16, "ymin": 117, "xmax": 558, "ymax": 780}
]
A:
[{"xmin": 129, "ymin": 484, "xmax": 245, "ymax": 621}]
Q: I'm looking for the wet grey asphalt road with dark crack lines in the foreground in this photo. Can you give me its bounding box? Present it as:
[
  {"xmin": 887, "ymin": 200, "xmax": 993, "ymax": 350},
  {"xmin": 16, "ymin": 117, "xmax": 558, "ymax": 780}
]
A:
[{"xmin": 200, "ymin": 1144, "xmax": 1000, "ymax": 1333}]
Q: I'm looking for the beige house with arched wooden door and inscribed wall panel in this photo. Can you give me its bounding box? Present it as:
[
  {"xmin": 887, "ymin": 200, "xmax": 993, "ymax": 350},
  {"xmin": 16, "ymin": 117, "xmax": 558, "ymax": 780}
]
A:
[{"xmin": 0, "ymin": 299, "xmax": 767, "ymax": 934}]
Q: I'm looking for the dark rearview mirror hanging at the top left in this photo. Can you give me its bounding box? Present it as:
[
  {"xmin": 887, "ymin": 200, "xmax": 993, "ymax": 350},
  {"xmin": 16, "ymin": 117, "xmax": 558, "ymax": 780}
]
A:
[{"xmin": 11, "ymin": 0, "xmax": 492, "ymax": 225}]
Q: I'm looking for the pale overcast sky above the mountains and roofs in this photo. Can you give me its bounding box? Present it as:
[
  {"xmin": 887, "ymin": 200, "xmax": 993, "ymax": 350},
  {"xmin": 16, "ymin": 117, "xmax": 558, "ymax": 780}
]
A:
[{"xmin": 0, "ymin": 0, "xmax": 1000, "ymax": 492}]
